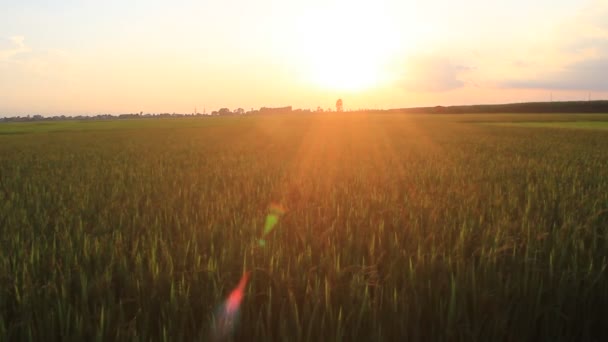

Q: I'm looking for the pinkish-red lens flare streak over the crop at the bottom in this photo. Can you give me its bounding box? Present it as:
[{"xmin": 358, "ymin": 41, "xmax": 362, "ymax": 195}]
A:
[{"xmin": 213, "ymin": 272, "xmax": 249, "ymax": 341}]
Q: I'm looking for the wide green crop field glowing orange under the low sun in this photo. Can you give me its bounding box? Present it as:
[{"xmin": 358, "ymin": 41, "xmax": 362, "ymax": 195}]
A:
[{"xmin": 0, "ymin": 114, "xmax": 608, "ymax": 341}]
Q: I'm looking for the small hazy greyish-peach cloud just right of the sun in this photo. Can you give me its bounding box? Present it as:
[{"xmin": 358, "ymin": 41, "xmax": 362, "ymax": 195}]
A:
[{"xmin": 399, "ymin": 57, "xmax": 470, "ymax": 92}]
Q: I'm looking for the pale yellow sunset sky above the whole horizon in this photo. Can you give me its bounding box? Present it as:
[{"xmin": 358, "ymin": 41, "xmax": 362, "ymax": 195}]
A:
[{"xmin": 0, "ymin": 0, "xmax": 608, "ymax": 116}]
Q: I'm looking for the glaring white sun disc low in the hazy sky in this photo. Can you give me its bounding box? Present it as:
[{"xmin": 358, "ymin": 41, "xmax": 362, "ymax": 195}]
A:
[{"xmin": 297, "ymin": 2, "xmax": 397, "ymax": 91}]
